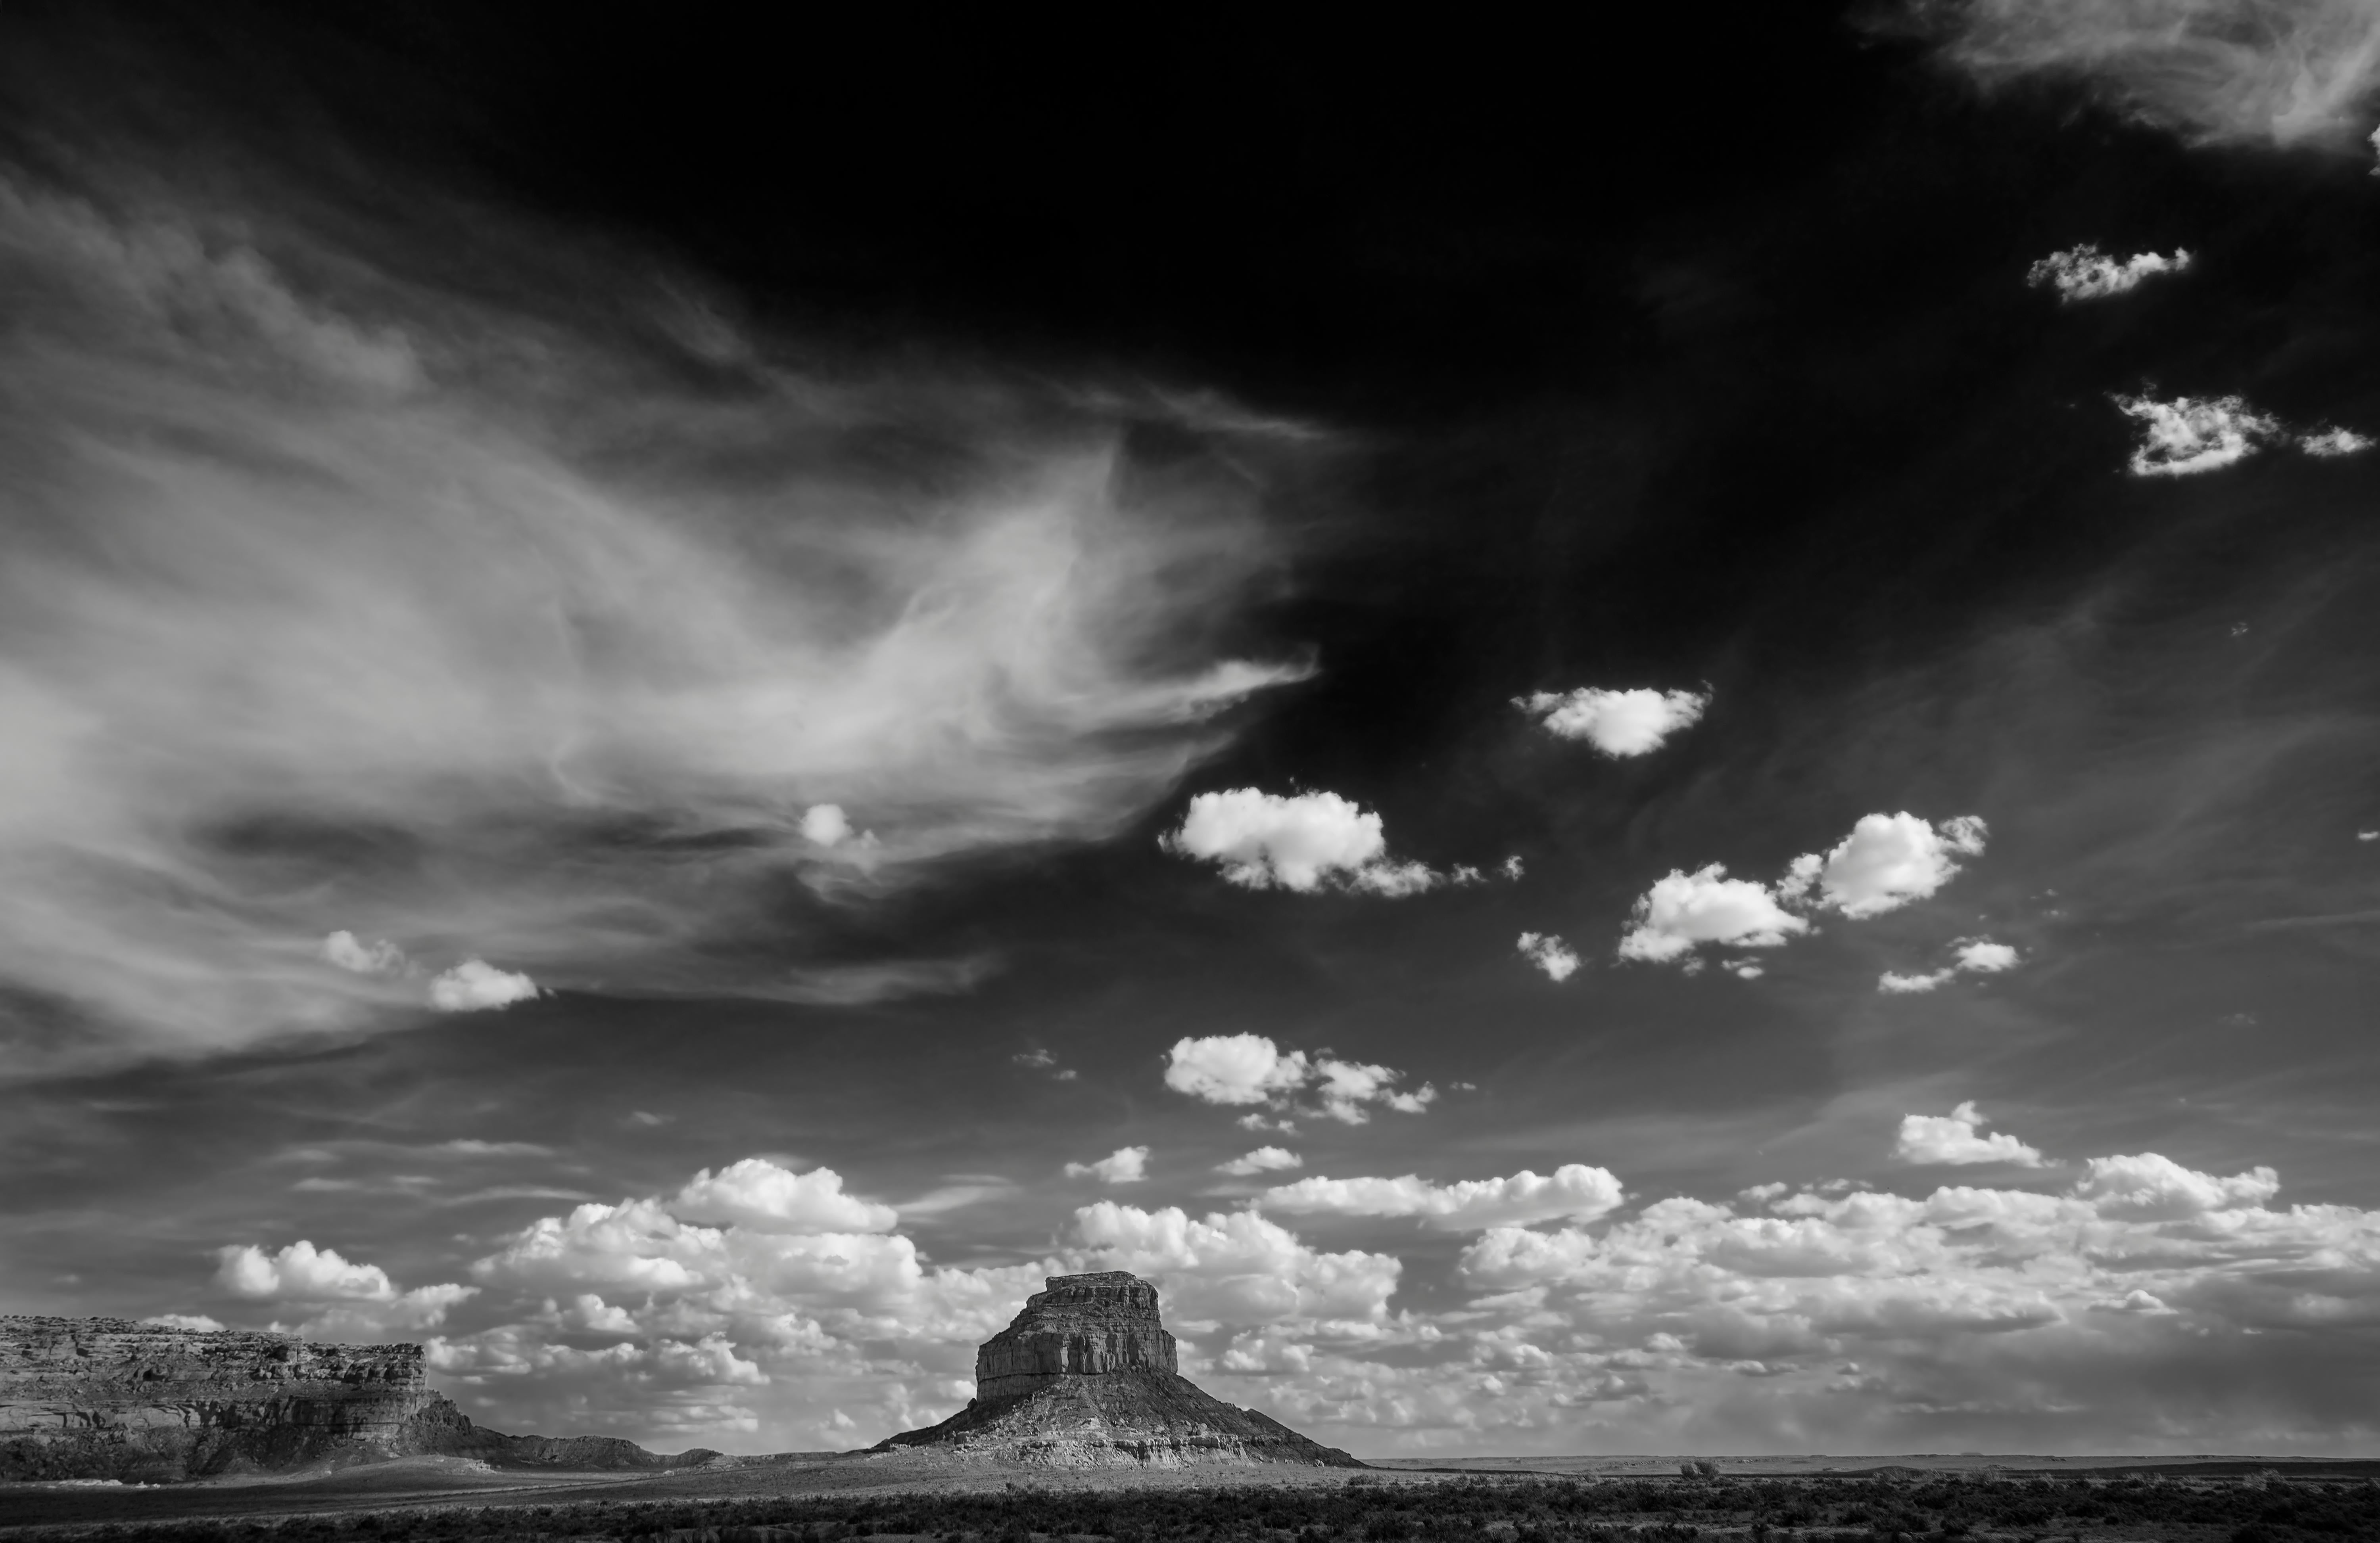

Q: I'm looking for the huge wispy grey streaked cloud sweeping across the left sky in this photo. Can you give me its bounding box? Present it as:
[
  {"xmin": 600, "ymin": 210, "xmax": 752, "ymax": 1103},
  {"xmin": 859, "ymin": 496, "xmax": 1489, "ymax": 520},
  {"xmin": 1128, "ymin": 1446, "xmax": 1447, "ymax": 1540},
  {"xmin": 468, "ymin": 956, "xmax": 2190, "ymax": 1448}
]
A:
[{"xmin": 0, "ymin": 162, "xmax": 1314, "ymax": 1069}]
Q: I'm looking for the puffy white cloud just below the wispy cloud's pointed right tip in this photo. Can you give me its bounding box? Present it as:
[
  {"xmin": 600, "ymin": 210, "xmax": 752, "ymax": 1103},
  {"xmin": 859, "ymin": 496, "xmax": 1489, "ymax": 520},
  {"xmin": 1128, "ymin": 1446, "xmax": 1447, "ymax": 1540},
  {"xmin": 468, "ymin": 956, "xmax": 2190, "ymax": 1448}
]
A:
[{"xmin": 1157, "ymin": 788, "xmax": 1449, "ymax": 900}]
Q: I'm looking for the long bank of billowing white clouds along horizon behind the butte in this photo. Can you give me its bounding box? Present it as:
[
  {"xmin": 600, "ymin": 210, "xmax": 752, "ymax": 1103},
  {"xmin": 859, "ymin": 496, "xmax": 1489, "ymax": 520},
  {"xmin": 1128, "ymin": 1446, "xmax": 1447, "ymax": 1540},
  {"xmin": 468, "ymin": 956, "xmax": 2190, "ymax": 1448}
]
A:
[{"xmin": 178, "ymin": 1102, "xmax": 2380, "ymax": 1453}]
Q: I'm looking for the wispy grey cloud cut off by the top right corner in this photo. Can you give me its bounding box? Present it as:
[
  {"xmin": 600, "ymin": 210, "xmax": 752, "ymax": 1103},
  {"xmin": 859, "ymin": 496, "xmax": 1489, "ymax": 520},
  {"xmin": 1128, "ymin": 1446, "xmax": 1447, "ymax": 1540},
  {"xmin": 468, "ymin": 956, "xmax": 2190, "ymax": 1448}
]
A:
[{"xmin": 1906, "ymin": 0, "xmax": 2380, "ymax": 150}]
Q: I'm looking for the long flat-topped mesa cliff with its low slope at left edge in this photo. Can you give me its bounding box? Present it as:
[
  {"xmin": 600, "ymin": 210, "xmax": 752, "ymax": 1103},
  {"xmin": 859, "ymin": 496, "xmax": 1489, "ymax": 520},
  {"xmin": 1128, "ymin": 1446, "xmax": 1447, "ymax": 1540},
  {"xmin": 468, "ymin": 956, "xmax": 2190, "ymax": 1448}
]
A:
[{"xmin": 0, "ymin": 1317, "xmax": 721, "ymax": 1484}]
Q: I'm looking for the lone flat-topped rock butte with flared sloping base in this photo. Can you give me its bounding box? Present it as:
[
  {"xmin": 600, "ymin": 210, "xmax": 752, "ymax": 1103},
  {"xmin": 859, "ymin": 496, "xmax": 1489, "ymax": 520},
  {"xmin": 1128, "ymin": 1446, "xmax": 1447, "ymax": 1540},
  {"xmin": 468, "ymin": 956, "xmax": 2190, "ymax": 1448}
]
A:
[{"xmin": 876, "ymin": 1269, "xmax": 1364, "ymax": 1467}]
